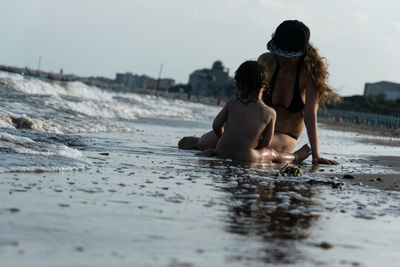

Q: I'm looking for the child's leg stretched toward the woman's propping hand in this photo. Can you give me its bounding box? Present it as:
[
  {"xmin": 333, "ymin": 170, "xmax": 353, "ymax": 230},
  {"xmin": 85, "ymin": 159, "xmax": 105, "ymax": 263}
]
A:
[{"xmin": 261, "ymin": 145, "xmax": 311, "ymax": 163}]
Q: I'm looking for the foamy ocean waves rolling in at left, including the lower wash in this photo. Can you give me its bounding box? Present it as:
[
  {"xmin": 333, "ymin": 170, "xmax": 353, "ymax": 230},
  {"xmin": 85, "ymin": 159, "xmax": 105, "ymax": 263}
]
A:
[{"xmin": 0, "ymin": 69, "xmax": 218, "ymax": 173}]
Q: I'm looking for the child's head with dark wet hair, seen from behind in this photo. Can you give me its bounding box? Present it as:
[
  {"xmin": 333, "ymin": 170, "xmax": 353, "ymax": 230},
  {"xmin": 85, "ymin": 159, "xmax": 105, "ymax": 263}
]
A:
[{"xmin": 234, "ymin": 60, "xmax": 268, "ymax": 102}]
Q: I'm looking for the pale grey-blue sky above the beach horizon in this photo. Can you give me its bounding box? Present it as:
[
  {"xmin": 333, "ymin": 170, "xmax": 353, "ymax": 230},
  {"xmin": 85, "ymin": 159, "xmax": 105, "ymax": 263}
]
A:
[{"xmin": 0, "ymin": 0, "xmax": 400, "ymax": 96}]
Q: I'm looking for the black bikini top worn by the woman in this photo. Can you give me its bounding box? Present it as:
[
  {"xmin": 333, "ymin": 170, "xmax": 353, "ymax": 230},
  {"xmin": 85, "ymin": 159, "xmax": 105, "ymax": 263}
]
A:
[{"xmin": 263, "ymin": 64, "xmax": 304, "ymax": 113}]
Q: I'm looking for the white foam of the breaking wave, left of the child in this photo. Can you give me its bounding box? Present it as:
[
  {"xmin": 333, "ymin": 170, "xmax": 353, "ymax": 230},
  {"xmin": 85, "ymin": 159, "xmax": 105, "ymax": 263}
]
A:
[{"xmin": 0, "ymin": 72, "xmax": 219, "ymax": 133}]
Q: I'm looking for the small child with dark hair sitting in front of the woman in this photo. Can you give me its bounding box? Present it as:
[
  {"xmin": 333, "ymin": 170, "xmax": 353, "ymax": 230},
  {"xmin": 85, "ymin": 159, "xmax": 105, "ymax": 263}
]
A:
[{"xmin": 196, "ymin": 61, "xmax": 311, "ymax": 163}]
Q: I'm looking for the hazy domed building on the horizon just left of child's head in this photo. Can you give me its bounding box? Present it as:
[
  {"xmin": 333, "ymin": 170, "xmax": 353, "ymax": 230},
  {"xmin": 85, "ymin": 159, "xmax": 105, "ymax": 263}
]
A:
[{"xmin": 189, "ymin": 60, "xmax": 232, "ymax": 96}]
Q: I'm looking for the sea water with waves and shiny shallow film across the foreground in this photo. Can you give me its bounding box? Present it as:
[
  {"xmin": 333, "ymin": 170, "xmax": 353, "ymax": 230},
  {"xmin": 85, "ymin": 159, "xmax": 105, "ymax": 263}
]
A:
[{"xmin": 0, "ymin": 72, "xmax": 400, "ymax": 266}]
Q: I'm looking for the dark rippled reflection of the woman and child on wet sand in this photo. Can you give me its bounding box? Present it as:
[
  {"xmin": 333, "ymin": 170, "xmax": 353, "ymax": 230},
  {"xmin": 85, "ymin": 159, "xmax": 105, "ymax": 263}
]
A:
[{"xmin": 201, "ymin": 160, "xmax": 319, "ymax": 264}]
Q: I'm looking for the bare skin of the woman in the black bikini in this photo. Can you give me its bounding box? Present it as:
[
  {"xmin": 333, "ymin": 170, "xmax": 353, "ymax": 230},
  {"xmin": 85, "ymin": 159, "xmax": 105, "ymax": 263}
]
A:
[{"xmin": 178, "ymin": 53, "xmax": 339, "ymax": 165}]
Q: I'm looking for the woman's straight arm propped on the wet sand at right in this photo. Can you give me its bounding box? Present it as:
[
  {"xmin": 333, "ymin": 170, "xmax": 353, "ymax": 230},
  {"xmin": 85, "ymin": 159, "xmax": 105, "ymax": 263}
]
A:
[{"xmin": 304, "ymin": 83, "xmax": 339, "ymax": 165}]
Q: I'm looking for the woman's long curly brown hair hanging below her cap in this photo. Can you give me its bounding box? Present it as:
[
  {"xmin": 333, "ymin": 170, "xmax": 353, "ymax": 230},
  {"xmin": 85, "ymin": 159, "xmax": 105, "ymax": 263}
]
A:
[{"xmin": 303, "ymin": 43, "xmax": 340, "ymax": 107}]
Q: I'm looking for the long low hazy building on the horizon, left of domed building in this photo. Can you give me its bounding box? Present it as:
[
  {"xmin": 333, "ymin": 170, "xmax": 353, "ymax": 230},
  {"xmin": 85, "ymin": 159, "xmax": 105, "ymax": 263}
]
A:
[{"xmin": 115, "ymin": 72, "xmax": 175, "ymax": 90}]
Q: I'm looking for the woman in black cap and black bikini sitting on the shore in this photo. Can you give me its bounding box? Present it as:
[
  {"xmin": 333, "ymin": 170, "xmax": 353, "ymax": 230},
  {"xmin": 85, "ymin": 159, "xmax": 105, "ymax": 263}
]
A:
[{"xmin": 178, "ymin": 20, "xmax": 338, "ymax": 165}]
